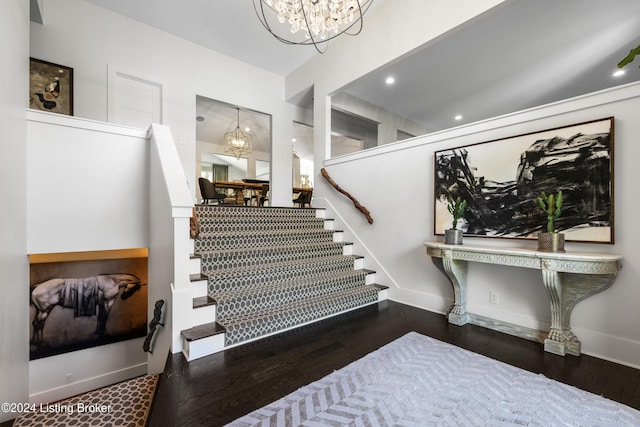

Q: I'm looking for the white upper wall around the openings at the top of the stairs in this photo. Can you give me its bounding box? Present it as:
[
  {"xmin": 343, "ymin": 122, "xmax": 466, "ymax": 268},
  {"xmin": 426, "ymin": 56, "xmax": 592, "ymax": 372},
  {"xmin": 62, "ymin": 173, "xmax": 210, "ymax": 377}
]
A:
[{"xmin": 31, "ymin": 0, "xmax": 294, "ymax": 205}]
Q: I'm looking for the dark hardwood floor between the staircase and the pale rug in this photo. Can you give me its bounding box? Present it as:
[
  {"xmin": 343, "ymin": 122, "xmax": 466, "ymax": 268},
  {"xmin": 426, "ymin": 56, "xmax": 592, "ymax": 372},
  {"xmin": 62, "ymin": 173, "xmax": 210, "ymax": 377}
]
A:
[{"xmin": 149, "ymin": 301, "xmax": 640, "ymax": 427}]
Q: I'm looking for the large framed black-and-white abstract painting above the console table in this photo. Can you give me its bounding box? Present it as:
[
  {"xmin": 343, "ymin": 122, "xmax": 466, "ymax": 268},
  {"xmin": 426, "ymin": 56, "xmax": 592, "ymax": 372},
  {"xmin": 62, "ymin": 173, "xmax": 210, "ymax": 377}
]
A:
[{"xmin": 434, "ymin": 117, "xmax": 614, "ymax": 244}]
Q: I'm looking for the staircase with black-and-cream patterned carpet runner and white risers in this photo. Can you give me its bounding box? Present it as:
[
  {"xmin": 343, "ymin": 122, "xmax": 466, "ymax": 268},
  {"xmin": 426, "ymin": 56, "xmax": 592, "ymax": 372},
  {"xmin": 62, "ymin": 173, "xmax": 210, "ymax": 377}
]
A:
[{"xmin": 182, "ymin": 205, "xmax": 387, "ymax": 360}]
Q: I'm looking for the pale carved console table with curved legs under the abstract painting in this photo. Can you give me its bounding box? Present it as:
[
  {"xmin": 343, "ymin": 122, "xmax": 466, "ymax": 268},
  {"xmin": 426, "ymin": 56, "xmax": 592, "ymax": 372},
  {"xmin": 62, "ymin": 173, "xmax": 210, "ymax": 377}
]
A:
[{"xmin": 424, "ymin": 242, "xmax": 622, "ymax": 356}]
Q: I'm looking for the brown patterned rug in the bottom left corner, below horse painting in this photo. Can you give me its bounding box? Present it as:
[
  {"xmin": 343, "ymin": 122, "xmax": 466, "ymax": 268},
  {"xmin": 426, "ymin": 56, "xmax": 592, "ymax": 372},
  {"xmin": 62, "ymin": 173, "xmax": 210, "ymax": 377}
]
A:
[{"xmin": 13, "ymin": 375, "xmax": 158, "ymax": 427}]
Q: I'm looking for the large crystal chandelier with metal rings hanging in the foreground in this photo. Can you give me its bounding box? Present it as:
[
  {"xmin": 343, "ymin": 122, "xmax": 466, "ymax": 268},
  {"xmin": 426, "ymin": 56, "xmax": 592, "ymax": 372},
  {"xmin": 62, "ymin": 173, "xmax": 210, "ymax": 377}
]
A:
[{"xmin": 253, "ymin": 0, "xmax": 373, "ymax": 53}]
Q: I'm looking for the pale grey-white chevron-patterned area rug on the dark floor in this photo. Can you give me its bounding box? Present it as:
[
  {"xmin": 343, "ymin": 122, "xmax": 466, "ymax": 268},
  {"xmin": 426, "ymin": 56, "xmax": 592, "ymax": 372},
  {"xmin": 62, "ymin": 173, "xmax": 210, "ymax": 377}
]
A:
[{"xmin": 229, "ymin": 332, "xmax": 640, "ymax": 427}]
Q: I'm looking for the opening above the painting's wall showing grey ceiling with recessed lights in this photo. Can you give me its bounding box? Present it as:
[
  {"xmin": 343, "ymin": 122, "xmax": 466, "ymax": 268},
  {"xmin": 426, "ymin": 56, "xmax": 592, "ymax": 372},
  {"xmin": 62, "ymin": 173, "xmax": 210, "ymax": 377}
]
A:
[{"xmin": 331, "ymin": 0, "xmax": 640, "ymax": 157}]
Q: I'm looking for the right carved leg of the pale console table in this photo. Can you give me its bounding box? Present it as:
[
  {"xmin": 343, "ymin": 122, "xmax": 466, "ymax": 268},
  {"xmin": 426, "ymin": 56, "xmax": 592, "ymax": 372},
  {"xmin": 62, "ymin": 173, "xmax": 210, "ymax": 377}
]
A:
[{"xmin": 542, "ymin": 270, "xmax": 616, "ymax": 356}]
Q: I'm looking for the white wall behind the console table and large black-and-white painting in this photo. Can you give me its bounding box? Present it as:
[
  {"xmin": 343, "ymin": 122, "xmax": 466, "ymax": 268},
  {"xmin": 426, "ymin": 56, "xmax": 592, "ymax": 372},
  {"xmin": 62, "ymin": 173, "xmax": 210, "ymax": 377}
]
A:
[{"xmin": 317, "ymin": 84, "xmax": 640, "ymax": 367}]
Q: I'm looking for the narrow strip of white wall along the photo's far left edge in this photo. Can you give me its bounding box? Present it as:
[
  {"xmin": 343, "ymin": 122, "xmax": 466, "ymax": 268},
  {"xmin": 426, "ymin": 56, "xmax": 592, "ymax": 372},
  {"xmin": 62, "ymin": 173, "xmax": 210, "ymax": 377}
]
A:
[{"xmin": 0, "ymin": 0, "xmax": 29, "ymax": 422}]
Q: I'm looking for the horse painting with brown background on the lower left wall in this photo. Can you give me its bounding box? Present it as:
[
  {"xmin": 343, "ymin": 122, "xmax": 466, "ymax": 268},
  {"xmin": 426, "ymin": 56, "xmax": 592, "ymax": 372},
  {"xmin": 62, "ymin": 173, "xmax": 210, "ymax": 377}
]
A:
[{"xmin": 29, "ymin": 248, "xmax": 148, "ymax": 360}]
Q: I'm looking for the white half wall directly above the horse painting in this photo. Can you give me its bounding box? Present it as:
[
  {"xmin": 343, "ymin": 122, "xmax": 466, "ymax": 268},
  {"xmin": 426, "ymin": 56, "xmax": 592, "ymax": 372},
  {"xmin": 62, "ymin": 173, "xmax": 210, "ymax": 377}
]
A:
[{"xmin": 27, "ymin": 111, "xmax": 149, "ymax": 253}]
